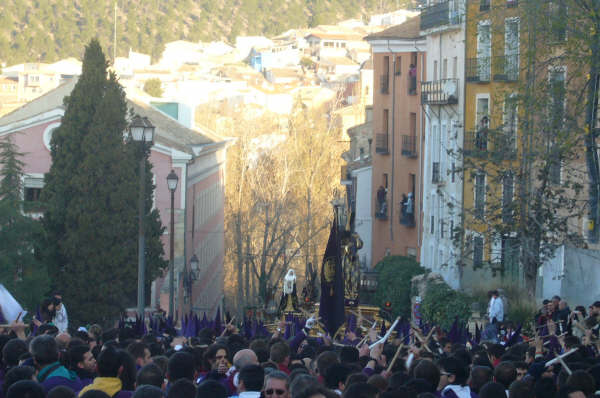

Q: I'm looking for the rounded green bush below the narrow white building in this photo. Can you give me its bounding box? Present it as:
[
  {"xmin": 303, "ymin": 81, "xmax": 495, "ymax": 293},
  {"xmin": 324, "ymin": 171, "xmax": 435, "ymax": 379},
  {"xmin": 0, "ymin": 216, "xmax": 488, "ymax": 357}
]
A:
[{"xmin": 421, "ymin": 282, "xmax": 471, "ymax": 330}]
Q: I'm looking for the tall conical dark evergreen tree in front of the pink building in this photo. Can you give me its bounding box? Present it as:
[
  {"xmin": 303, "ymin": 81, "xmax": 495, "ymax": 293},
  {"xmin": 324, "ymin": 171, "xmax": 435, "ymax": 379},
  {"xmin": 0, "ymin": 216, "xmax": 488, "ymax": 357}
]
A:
[{"xmin": 42, "ymin": 39, "xmax": 165, "ymax": 323}]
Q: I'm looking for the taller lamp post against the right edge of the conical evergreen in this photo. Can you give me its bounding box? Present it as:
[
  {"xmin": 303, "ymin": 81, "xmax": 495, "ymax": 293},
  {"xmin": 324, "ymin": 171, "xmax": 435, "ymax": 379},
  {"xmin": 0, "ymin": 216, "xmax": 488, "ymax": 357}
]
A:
[{"xmin": 129, "ymin": 115, "xmax": 154, "ymax": 321}]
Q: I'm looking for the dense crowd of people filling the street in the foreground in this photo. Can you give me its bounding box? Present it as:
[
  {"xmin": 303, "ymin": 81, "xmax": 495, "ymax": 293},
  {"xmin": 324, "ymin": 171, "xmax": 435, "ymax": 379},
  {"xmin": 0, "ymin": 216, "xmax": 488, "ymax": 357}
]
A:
[{"xmin": 0, "ymin": 292, "xmax": 600, "ymax": 398}]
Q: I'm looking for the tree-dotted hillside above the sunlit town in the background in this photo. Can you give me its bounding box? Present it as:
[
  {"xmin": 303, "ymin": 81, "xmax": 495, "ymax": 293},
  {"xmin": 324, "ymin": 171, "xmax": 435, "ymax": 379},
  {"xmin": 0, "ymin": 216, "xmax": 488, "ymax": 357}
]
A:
[{"xmin": 0, "ymin": 0, "xmax": 403, "ymax": 65}]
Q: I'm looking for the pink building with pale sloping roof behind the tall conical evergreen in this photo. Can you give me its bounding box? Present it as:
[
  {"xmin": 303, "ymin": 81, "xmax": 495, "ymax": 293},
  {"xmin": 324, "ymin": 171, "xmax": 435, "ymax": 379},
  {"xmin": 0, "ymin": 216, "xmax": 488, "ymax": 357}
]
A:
[{"xmin": 0, "ymin": 79, "xmax": 226, "ymax": 315}]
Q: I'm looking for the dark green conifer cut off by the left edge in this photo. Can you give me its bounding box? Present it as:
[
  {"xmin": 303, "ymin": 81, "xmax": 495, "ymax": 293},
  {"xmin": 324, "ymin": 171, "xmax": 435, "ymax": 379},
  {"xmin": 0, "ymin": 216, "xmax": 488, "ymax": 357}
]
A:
[{"xmin": 0, "ymin": 135, "xmax": 49, "ymax": 311}]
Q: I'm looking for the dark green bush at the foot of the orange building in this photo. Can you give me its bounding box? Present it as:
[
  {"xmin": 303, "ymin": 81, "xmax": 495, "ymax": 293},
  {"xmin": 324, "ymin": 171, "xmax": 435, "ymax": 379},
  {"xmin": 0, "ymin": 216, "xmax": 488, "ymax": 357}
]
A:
[{"xmin": 373, "ymin": 256, "xmax": 427, "ymax": 318}]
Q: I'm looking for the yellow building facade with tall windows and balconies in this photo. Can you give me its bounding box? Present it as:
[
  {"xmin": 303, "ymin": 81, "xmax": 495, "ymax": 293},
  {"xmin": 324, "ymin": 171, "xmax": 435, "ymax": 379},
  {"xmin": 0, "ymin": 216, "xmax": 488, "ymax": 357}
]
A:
[{"xmin": 461, "ymin": 0, "xmax": 523, "ymax": 287}]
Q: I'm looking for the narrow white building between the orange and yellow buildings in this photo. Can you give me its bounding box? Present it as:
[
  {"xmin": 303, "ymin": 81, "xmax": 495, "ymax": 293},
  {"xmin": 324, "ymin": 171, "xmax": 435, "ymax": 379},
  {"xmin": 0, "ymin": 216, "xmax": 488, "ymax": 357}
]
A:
[{"xmin": 420, "ymin": 0, "xmax": 465, "ymax": 289}]
